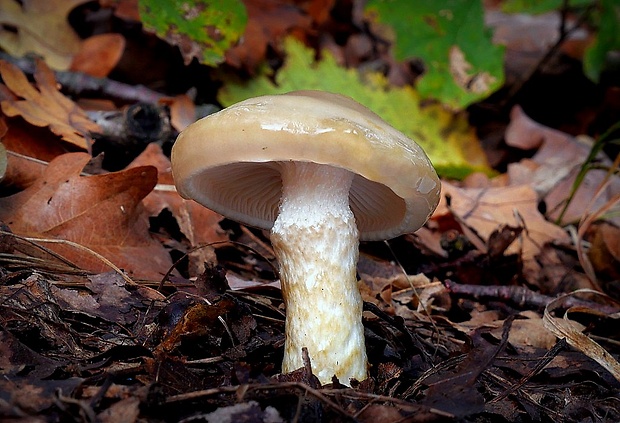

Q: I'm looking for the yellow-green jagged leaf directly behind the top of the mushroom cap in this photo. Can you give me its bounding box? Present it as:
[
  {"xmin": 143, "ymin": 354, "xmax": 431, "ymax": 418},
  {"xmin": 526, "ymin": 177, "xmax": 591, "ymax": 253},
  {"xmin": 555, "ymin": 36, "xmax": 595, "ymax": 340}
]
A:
[{"xmin": 218, "ymin": 38, "xmax": 491, "ymax": 178}]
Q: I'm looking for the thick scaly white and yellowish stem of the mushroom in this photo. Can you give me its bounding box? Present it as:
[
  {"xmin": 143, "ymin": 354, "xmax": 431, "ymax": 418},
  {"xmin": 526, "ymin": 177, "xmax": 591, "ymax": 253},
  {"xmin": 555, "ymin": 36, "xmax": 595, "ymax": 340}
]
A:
[{"xmin": 271, "ymin": 162, "xmax": 367, "ymax": 384}]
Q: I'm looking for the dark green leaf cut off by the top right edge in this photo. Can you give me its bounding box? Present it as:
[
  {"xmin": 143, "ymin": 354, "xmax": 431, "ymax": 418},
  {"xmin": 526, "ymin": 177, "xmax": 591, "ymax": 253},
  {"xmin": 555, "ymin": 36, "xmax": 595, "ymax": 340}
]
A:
[{"xmin": 583, "ymin": 0, "xmax": 620, "ymax": 82}]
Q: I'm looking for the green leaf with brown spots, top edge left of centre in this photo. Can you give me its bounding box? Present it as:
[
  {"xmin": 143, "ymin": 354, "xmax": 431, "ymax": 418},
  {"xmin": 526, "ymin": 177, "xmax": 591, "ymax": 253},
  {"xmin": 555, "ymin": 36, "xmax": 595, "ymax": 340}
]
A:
[{"xmin": 138, "ymin": 0, "xmax": 248, "ymax": 66}]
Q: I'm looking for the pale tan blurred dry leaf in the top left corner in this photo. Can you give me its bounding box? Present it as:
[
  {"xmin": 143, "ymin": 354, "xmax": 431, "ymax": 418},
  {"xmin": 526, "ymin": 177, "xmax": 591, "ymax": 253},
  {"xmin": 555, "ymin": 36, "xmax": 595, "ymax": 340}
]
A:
[{"xmin": 0, "ymin": 0, "xmax": 88, "ymax": 70}]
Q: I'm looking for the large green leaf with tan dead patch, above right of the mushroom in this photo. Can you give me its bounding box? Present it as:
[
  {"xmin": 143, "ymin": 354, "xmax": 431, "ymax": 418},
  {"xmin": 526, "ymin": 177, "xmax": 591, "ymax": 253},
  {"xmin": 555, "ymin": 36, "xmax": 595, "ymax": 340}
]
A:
[{"xmin": 365, "ymin": 0, "xmax": 504, "ymax": 110}]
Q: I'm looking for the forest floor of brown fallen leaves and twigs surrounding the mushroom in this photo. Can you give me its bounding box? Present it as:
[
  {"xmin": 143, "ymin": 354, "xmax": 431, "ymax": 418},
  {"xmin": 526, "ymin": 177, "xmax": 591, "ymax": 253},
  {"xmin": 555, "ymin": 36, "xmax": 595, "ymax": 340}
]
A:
[{"xmin": 0, "ymin": 1, "xmax": 620, "ymax": 422}]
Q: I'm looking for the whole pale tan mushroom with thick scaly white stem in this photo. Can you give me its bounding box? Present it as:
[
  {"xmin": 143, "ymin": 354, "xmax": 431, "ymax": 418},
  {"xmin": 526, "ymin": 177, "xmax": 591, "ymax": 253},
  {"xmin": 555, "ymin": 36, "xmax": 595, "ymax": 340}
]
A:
[{"xmin": 172, "ymin": 91, "xmax": 440, "ymax": 384}]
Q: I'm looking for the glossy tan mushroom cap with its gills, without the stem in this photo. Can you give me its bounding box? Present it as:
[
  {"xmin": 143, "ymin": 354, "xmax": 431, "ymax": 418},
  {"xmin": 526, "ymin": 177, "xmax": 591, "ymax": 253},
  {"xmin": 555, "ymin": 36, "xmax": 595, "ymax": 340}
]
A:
[{"xmin": 172, "ymin": 91, "xmax": 440, "ymax": 240}]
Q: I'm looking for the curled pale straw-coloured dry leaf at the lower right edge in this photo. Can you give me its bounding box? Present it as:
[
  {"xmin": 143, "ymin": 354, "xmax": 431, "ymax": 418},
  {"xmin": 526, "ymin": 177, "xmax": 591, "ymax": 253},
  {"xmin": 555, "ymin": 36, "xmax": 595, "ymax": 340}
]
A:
[{"xmin": 543, "ymin": 289, "xmax": 620, "ymax": 381}]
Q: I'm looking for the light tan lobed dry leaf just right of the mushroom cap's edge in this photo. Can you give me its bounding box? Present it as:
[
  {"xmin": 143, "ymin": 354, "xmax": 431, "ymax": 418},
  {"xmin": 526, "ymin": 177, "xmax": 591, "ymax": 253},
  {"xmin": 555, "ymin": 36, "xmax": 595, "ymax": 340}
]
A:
[{"xmin": 433, "ymin": 182, "xmax": 569, "ymax": 281}]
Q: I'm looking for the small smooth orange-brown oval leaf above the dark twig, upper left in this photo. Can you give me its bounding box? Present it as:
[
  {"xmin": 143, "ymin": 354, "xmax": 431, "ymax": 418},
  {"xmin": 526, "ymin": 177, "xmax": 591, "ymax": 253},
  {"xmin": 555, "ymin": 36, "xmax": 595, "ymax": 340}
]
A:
[{"xmin": 70, "ymin": 34, "xmax": 126, "ymax": 78}]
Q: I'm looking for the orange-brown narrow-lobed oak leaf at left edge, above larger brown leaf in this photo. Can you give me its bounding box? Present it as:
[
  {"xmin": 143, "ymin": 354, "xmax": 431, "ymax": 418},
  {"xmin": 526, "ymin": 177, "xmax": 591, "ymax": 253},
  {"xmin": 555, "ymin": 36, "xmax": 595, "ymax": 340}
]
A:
[{"xmin": 0, "ymin": 60, "xmax": 100, "ymax": 149}]
